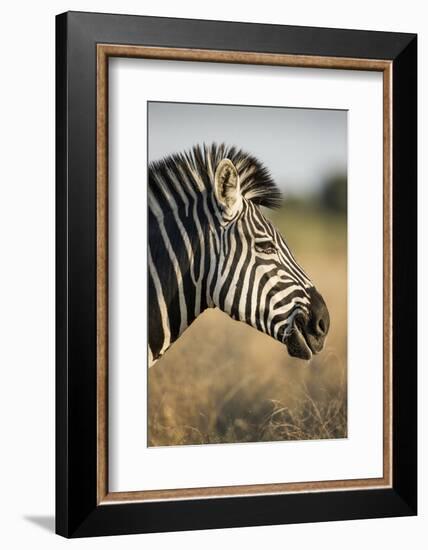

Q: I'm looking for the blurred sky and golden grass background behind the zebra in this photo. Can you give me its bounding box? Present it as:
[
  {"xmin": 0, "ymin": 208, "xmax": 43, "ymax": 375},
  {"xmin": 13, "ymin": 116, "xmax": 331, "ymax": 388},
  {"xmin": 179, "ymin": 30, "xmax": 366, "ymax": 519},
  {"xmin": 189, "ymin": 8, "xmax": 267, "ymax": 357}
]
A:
[{"xmin": 148, "ymin": 102, "xmax": 347, "ymax": 446}]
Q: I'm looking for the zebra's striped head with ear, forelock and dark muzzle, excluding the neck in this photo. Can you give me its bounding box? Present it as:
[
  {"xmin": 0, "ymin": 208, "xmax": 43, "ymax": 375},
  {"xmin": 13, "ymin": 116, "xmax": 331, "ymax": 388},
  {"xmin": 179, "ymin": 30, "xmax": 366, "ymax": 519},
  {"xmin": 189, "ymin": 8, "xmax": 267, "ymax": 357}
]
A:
[{"xmin": 206, "ymin": 148, "xmax": 330, "ymax": 360}]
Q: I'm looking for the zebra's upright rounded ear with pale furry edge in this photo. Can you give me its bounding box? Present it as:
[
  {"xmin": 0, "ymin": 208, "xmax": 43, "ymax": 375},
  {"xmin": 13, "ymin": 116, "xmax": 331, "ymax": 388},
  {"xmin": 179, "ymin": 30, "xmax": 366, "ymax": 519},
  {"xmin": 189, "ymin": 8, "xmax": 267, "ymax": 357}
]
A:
[{"xmin": 214, "ymin": 159, "xmax": 242, "ymax": 218}]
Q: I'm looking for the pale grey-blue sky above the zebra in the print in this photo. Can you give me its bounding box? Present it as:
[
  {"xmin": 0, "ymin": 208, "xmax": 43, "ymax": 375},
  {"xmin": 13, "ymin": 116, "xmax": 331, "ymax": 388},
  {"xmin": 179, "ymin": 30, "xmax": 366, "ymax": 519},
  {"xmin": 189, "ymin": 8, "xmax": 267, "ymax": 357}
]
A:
[{"xmin": 148, "ymin": 102, "xmax": 347, "ymax": 195}]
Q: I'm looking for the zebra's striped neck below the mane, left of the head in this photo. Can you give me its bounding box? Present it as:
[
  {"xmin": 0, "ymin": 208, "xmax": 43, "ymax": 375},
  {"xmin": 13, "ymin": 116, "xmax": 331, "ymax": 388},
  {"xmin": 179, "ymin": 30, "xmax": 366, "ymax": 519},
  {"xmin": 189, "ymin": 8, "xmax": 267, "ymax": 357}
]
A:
[{"xmin": 148, "ymin": 203, "xmax": 215, "ymax": 361}]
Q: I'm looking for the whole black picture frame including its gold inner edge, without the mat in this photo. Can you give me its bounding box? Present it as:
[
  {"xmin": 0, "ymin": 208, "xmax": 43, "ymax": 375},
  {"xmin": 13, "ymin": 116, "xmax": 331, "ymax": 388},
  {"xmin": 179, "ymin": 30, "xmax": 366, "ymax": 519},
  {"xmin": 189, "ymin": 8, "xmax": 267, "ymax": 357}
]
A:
[{"xmin": 56, "ymin": 12, "xmax": 417, "ymax": 537}]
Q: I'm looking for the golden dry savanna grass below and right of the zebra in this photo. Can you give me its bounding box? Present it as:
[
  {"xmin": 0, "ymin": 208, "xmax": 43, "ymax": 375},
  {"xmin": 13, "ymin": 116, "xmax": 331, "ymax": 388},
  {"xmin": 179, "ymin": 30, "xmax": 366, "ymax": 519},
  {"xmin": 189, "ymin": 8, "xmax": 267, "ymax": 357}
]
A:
[{"xmin": 148, "ymin": 201, "xmax": 347, "ymax": 446}]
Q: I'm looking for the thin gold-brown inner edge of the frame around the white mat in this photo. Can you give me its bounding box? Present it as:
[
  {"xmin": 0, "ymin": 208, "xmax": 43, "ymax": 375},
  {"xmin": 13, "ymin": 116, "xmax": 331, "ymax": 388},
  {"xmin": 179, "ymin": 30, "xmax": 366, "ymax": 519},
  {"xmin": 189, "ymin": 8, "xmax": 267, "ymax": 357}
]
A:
[{"xmin": 96, "ymin": 44, "xmax": 392, "ymax": 505}]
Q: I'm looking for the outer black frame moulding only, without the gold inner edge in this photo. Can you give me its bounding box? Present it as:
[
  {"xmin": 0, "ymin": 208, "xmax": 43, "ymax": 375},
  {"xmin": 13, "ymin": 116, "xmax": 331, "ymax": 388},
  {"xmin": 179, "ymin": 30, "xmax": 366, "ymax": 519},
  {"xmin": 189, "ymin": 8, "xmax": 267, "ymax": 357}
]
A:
[{"xmin": 56, "ymin": 12, "xmax": 417, "ymax": 537}]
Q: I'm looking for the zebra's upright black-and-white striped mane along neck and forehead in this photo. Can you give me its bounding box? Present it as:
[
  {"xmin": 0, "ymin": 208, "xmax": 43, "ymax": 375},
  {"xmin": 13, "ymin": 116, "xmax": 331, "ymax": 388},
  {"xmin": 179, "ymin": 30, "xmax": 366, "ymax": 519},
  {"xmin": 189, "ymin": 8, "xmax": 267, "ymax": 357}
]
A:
[{"xmin": 149, "ymin": 143, "xmax": 282, "ymax": 208}]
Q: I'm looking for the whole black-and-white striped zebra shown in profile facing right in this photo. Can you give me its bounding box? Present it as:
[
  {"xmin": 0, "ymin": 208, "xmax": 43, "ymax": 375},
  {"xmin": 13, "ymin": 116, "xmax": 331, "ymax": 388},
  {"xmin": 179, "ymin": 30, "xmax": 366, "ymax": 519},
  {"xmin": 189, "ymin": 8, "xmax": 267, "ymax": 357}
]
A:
[{"xmin": 148, "ymin": 143, "xmax": 330, "ymax": 366}]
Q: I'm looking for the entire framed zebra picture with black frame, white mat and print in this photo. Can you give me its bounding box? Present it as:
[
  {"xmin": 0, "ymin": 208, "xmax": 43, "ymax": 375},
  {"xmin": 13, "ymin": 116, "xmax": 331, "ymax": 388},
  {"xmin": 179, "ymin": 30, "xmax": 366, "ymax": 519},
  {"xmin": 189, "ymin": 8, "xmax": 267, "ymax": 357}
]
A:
[{"xmin": 56, "ymin": 12, "xmax": 417, "ymax": 537}]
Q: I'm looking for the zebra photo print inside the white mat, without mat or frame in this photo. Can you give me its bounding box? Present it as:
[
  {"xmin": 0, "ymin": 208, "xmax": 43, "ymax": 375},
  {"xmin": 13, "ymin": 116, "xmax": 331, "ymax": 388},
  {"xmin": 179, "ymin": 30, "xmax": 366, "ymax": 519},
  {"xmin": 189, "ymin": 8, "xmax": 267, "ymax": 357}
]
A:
[{"xmin": 147, "ymin": 101, "xmax": 347, "ymax": 447}]
